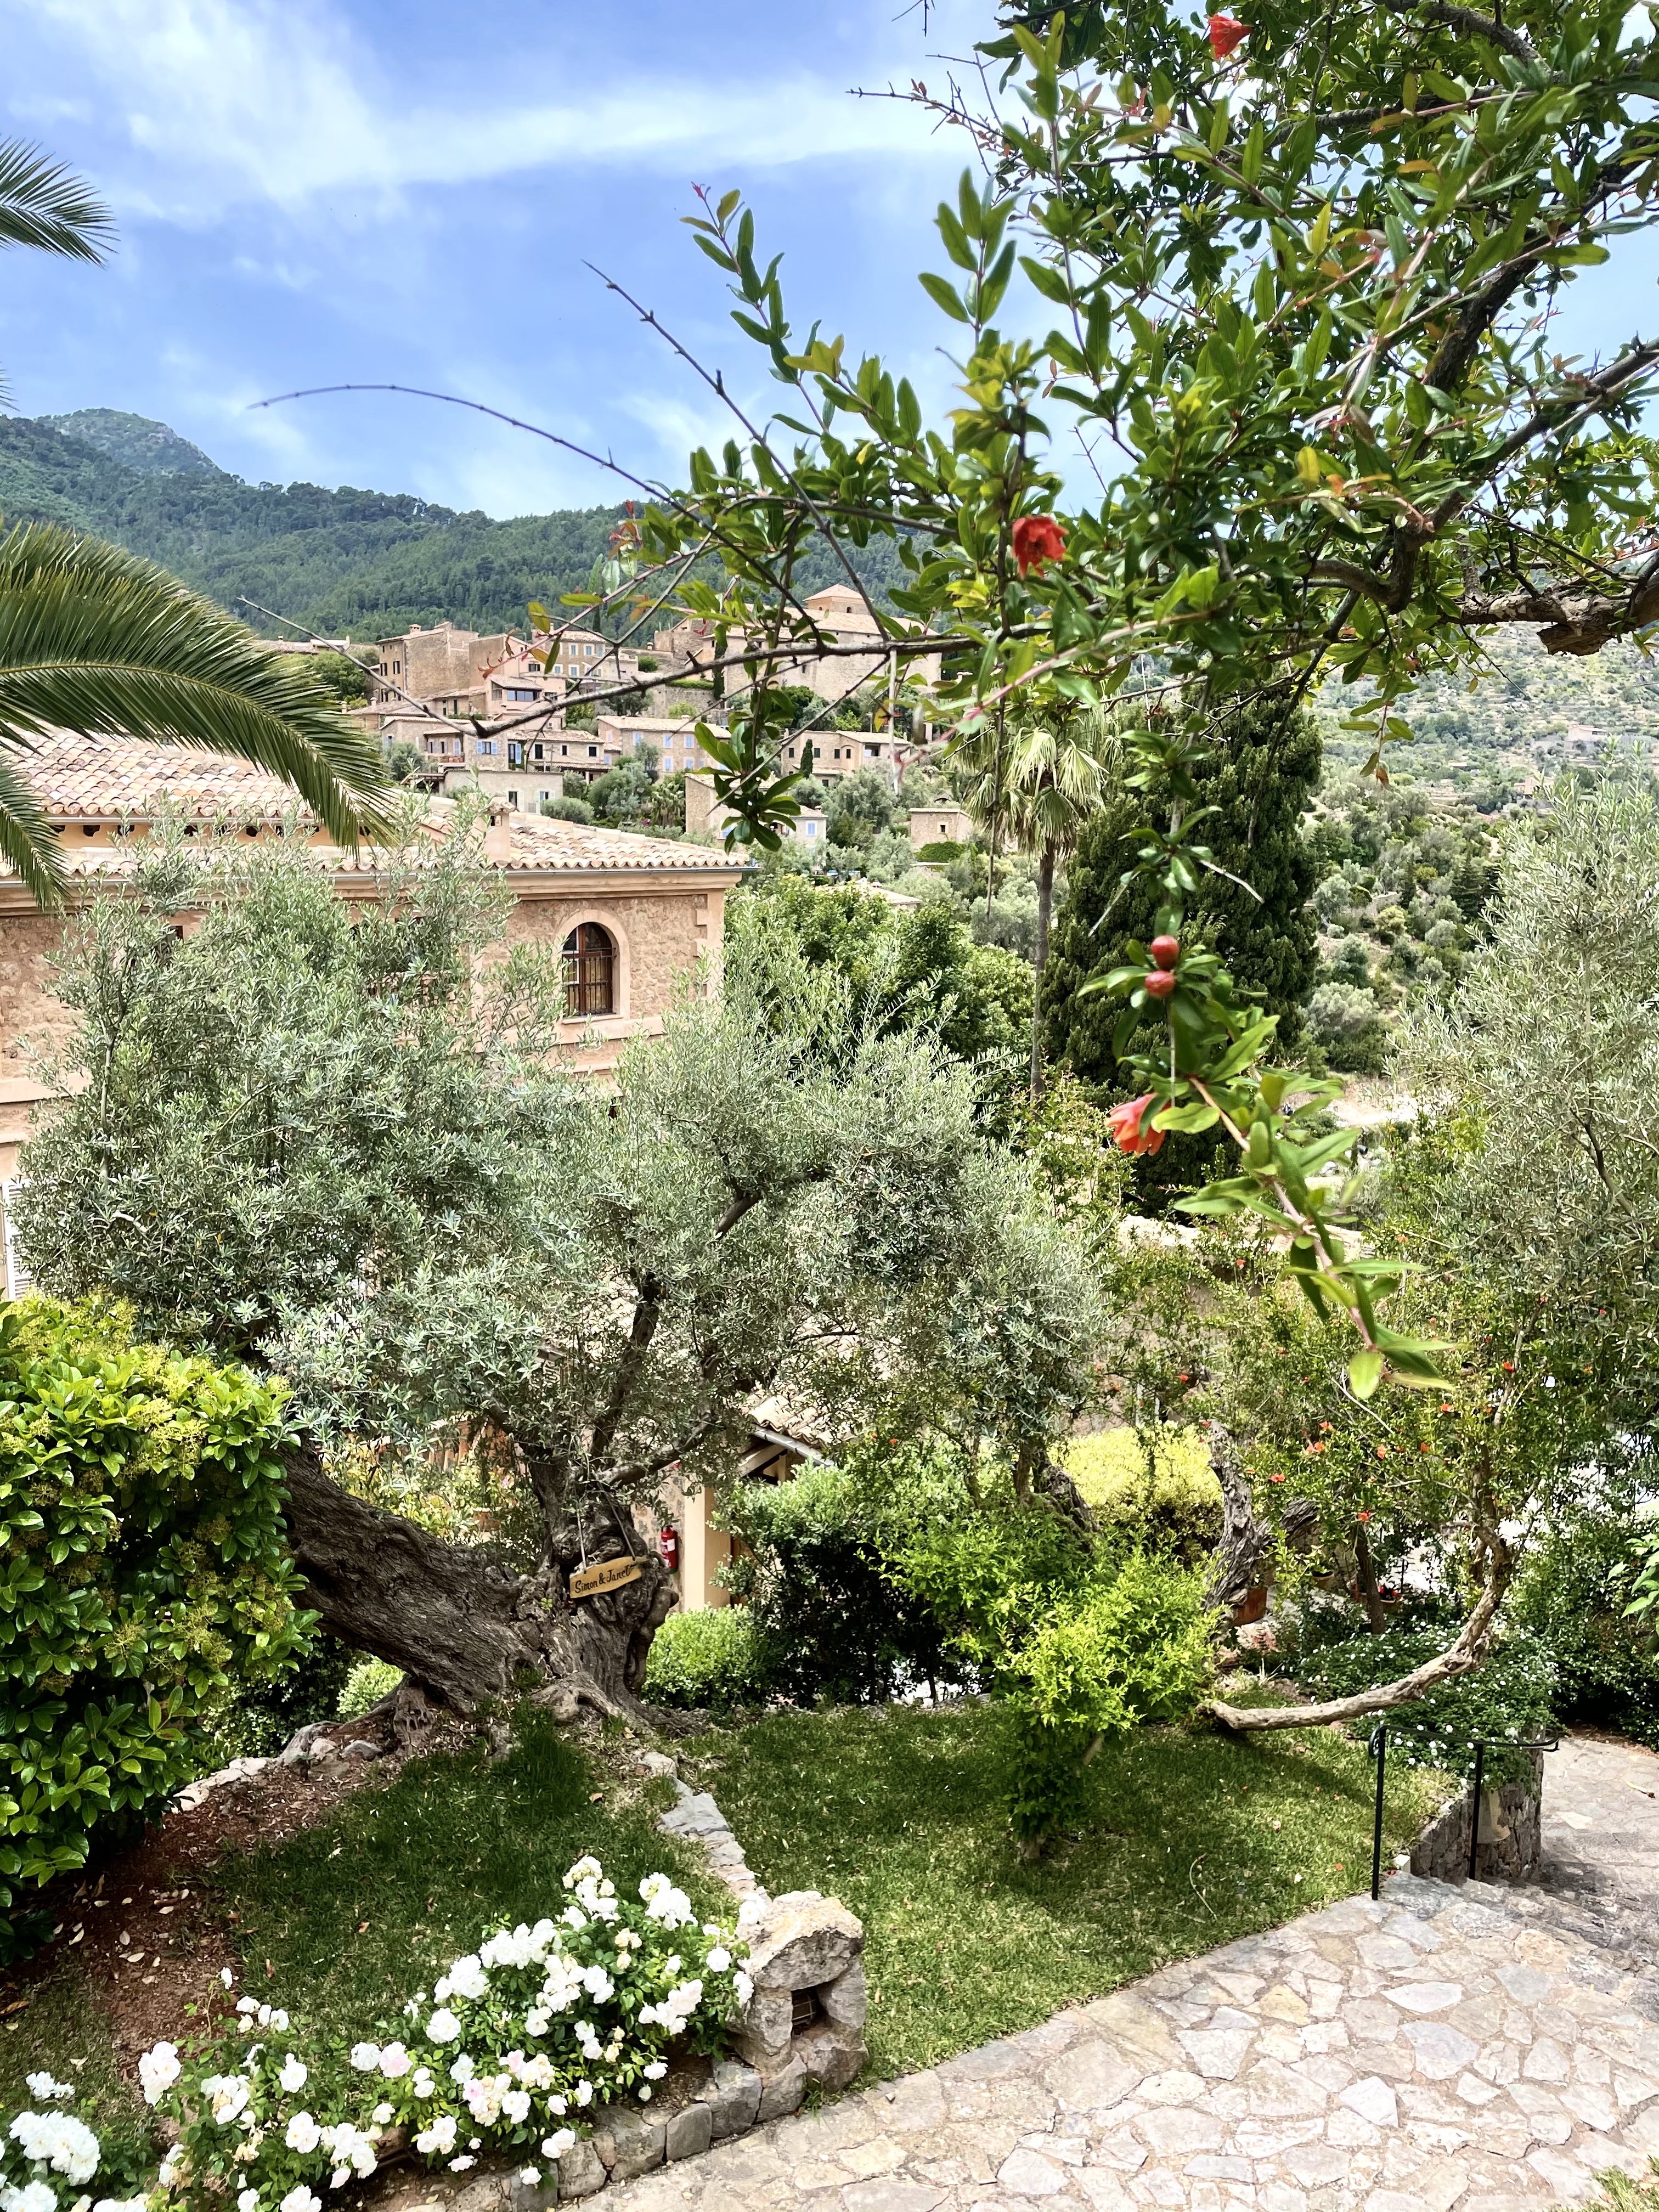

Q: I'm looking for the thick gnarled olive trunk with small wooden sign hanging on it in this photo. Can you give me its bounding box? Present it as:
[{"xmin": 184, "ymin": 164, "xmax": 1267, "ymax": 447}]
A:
[{"xmin": 287, "ymin": 1451, "xmax": 675, "ymax": 1717}]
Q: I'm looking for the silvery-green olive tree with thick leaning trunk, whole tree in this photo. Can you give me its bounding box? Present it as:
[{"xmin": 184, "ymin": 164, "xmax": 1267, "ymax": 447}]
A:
[{"xmin": 22, "ymin": 845, "xmax": 1093, "ymax": 1712}]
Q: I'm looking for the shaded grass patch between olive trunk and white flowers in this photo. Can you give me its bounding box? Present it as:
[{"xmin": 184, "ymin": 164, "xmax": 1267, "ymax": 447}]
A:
[{"xmin": 212, "ymin": 1719, "xmax": 735, "ymax": 2033}]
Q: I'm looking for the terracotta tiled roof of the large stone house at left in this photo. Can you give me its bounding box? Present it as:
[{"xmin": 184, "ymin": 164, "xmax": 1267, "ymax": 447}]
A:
[{"xmin": 0, "ymin": 735, "xmax": 743, "ymax": 881}]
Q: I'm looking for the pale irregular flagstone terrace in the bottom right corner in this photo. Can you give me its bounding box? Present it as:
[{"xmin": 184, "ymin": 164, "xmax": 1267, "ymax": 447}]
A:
[{"xmin": 604, "ymin": 1736, "xmax": 1659, "ymax": 2212}]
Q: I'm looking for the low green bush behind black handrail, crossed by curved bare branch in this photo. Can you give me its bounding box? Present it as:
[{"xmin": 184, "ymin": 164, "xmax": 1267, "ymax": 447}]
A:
[{"xmin": 1303, "ymin": 1628, "xmax": 1555, "ymax": 1783}]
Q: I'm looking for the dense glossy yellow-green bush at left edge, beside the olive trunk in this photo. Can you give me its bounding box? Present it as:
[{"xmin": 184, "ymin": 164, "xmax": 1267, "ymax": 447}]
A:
[{"xmin": 0, "ymin": 1299, "xmax": 307, "ymax": 1905}]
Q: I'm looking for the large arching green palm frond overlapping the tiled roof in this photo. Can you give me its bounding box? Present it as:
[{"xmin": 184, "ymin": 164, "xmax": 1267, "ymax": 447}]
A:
[{"xmin": 0, "ymin": 522, "xmax": 392, "ymax": 898}]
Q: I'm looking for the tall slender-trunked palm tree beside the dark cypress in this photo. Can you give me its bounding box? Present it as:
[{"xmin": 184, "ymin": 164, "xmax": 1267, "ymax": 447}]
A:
[{"xmin": 958, "ymin": 699, "xmax": 1117, "ymax": 1106}]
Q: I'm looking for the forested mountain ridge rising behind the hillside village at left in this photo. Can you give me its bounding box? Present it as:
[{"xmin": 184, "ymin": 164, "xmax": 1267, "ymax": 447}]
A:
[{"xmin": 0, "ymin": 407, "xmax": 911, "ymax": 639}]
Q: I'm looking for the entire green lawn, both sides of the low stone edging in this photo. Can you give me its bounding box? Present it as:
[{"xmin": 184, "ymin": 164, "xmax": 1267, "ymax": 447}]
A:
[{"xmin": 0, "ymin": 1706, "xmax": 1444, "ymax": 2114}]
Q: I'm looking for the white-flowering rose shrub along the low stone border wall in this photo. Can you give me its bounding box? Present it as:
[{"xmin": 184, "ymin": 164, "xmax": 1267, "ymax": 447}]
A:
[{"xmin": 133, "ymin": 1858, "xmax": 750, "ymax": 2212}]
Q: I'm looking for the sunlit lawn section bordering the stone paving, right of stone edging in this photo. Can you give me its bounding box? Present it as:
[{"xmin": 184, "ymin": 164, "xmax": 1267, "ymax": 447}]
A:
[{"xmin": 681, "ymin": 1706, "xmax": 1444, "ymax": 2075}]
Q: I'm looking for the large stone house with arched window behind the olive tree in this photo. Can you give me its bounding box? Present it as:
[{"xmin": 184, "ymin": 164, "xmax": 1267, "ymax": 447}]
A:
[{"xmin": 0, "ymin": 735, "xmax": 743, "ymax": 1290}]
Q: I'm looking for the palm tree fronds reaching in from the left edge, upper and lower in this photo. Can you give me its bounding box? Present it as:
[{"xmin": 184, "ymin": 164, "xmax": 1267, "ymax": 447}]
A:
[{"xmin": 0, "ymin": 142, "xmax": 390, "ymax": 907}]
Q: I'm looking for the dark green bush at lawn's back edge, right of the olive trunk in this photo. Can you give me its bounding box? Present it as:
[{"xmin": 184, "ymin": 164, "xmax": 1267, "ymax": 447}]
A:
[{"xmin": 728, "ymin": 1447, "xmax": 960, "ymax": 1703}]
